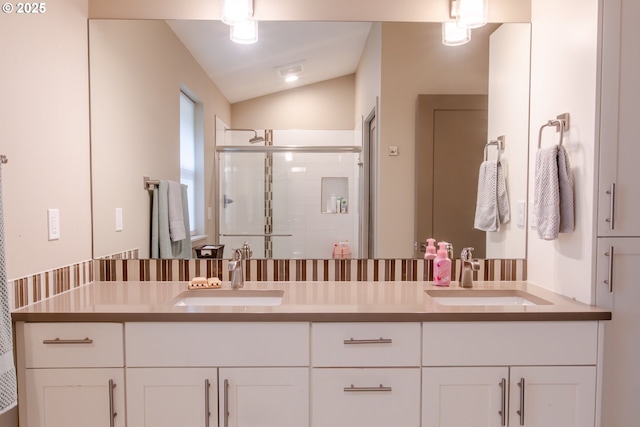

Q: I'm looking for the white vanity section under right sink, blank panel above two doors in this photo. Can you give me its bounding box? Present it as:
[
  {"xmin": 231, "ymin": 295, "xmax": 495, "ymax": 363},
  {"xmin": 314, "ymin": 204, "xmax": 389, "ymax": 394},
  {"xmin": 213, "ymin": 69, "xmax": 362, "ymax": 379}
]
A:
[{"xmin": 422, "ymin": 322, "xmax": 598, "ymax": 427}]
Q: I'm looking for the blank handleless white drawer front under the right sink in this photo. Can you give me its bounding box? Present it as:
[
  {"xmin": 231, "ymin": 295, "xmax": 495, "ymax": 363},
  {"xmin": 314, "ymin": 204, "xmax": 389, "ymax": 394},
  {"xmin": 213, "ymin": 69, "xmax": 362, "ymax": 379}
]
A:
[{"xmin": 422, "ymin": 321, "xmax": 598, "ymax": 366}]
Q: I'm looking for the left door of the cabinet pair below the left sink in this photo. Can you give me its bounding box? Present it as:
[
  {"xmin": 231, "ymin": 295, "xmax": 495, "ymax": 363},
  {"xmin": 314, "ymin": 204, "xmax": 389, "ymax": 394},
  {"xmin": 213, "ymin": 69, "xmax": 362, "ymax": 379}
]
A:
[{"xmin": 127, "ymin": 368, "xmax": 218, "ymax": 427}]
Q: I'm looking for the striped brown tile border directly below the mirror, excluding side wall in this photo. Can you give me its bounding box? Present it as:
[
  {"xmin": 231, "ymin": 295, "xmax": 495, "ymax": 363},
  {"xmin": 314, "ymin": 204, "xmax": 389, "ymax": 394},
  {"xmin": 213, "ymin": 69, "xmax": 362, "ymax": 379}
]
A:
[{"xmin": 95, "ymin": 259, "xmax": 527, "ymax": 282}]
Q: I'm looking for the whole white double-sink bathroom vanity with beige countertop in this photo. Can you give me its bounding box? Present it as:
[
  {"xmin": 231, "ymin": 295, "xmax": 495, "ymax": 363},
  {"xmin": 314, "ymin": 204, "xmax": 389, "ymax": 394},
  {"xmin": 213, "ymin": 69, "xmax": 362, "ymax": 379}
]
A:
[{"xmin": 13, "ymin": 282, "xmax": 611, "ymax": 427}]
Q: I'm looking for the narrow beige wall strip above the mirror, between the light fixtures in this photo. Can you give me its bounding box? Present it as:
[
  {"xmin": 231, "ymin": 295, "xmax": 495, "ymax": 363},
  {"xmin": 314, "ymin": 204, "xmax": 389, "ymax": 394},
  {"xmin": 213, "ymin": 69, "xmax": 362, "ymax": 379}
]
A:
[{"xmin": 90, "ymin": 0, "xmax": 531, "ymax": 22}]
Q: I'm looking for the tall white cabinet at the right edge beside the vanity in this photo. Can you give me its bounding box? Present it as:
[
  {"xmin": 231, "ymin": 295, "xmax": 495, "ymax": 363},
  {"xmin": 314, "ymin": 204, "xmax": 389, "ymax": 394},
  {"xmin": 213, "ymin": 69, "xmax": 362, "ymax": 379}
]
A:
[{"xmin": 595, "ymin": 0, "xmax": 640, "ymax": 427}]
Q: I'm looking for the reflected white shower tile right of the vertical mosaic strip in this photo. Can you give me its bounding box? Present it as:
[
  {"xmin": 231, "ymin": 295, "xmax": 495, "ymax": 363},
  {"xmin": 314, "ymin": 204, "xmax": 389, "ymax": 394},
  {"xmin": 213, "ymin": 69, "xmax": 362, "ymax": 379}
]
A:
[{"xmin": 273, "ymin": 130, "xmax": 359, "ymax": 258}]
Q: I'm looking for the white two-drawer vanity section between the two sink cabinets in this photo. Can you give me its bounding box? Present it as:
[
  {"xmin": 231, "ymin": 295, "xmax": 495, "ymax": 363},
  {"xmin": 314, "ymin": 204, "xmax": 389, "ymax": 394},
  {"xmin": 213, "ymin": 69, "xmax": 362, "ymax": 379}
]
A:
[{"xmin": 311, "ymin": 323, "xmax": 421, "ymax": 427}]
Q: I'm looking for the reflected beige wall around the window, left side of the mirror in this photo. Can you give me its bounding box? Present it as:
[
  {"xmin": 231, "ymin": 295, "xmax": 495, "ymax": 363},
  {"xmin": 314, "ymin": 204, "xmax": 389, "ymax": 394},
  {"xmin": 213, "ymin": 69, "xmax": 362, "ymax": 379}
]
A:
[{"xmin": 90, "ymin": 20, "xmax": 230, "ymax": 258}]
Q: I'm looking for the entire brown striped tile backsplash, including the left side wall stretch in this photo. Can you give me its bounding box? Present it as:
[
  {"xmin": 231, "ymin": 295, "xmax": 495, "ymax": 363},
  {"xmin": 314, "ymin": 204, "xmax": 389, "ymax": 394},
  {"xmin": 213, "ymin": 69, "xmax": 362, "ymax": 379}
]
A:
[{"xmin": 8, "ymin": 253, "xmax": 527, "ymax": 310}]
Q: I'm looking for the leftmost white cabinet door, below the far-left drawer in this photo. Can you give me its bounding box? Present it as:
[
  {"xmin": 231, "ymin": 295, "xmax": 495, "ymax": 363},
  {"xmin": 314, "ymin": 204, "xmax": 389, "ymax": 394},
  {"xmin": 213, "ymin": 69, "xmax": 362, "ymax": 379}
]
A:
[{"xmin": 20, "ymin": 368, "xmax": 125, "ymax": 427}]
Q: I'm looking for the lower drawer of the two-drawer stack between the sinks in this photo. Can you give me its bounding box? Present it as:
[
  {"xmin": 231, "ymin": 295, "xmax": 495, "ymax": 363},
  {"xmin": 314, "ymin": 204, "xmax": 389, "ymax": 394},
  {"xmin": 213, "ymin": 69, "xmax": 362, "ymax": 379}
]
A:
[{"xmin": 311, "ymin": 368, "xmax": 420, "ymax": 427}]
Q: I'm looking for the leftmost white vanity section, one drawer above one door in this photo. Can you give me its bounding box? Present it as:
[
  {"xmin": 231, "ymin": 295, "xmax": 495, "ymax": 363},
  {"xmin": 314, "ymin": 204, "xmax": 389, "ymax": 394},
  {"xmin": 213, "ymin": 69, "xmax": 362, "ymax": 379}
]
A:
[{"xmin": 16, "ymin": 323, "xmax": 125, "ymax": 427}]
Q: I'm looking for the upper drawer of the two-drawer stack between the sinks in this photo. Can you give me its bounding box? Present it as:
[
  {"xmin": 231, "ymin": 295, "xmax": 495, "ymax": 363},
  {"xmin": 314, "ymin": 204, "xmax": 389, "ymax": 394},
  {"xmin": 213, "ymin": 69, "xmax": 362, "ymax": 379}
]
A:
[{"xmin": 311, "ymin": 322, "xmax": 420, "ymax": 367}]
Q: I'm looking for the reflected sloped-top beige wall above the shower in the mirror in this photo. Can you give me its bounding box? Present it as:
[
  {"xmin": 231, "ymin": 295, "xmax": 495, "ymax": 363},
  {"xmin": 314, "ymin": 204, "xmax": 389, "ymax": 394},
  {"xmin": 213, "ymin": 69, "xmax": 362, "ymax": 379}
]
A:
[{"xmin": 231, "ymin": 74, "xmax": 355, "ymax": 130}]
